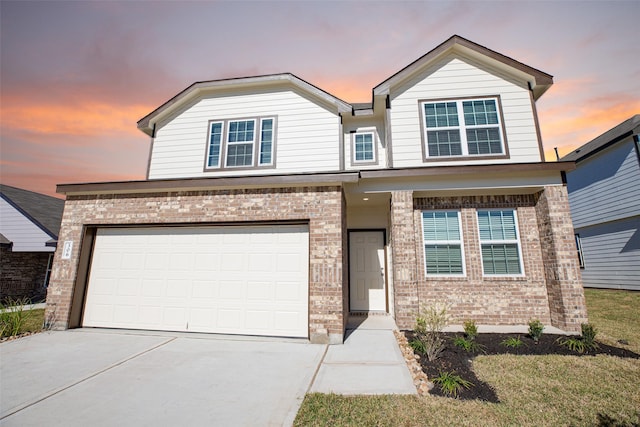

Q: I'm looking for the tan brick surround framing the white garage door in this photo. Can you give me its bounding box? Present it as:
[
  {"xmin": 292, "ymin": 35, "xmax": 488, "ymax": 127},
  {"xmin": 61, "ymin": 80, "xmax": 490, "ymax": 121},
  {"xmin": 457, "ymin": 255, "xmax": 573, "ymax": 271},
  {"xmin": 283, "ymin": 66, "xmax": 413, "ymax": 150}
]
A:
[{"xmin": 47, "ymin": 186, "xmax": 346, "ymax": 343}]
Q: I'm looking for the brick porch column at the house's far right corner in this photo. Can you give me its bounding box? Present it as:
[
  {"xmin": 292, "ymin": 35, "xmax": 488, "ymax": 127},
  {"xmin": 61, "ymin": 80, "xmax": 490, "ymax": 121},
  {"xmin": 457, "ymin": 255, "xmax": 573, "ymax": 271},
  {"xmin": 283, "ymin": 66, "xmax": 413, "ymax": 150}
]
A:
[{"xmin": 536, "ymin": 185, "xmax": 587, "ymax": 332}]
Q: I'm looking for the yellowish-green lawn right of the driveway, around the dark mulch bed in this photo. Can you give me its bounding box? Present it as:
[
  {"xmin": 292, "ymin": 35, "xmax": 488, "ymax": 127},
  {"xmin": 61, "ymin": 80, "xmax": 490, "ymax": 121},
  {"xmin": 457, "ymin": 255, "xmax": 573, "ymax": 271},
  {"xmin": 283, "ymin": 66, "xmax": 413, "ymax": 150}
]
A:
[{"xmin": 295, "ymin": 289, "xmax": 640, "ymax": 427}]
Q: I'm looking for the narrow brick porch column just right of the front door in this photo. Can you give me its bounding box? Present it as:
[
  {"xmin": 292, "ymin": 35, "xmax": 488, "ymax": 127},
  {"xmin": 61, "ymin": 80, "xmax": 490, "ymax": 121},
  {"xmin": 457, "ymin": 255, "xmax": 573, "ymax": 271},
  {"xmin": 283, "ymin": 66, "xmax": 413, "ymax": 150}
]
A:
[{"xmin": 390, "ymin": 191, "xmax": 419, "ymax": 328}]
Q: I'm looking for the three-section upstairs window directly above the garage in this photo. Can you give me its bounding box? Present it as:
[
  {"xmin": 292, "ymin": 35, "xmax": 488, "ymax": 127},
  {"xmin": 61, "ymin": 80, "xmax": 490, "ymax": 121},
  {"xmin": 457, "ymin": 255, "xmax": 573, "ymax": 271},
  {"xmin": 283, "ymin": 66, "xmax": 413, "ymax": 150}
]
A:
[{"xmin": 205, "ymin": 117, "xmax": 276, "ymax": 169}]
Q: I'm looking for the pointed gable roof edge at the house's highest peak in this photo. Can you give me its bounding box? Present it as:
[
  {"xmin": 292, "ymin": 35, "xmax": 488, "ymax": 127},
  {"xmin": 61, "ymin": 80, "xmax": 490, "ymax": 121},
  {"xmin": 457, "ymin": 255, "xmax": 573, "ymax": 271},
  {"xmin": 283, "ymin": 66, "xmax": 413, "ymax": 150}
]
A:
[{"xmin": 373, "ymin": 35, "xmax": 553, "ymax": 99}]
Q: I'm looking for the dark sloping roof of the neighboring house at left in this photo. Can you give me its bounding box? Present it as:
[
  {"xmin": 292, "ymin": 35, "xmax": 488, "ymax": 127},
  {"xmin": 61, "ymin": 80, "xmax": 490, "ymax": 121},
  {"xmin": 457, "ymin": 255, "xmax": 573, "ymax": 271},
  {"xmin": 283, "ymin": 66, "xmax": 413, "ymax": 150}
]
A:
[{"xmin": 0, "ymin": 184, "xmax": 64, "ymax": 240}]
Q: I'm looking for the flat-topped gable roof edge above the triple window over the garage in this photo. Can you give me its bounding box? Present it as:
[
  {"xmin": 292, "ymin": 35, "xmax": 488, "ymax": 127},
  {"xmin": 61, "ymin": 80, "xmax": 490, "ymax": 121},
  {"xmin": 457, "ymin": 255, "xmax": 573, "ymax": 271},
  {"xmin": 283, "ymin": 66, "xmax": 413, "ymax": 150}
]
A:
[{"xmin": 138, "ymin": 73, "xmax": 352, "ymax": 136}]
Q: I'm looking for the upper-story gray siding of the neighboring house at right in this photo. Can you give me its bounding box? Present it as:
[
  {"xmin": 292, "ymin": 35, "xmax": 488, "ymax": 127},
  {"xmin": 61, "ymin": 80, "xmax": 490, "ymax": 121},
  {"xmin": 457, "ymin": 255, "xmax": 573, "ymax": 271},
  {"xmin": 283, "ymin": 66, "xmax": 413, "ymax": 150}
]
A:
[{"xmin": 567, "ymin": 137, "xmax": 640, "ymax": 228}]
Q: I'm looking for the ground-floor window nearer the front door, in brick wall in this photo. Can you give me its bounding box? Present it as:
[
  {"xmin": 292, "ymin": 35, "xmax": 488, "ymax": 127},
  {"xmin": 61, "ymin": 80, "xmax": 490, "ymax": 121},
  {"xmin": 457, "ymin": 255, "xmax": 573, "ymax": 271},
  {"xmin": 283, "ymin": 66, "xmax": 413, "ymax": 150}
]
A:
[{"xmin": 422, "ymin": 211, "xmax": 465, "ymax": 276}]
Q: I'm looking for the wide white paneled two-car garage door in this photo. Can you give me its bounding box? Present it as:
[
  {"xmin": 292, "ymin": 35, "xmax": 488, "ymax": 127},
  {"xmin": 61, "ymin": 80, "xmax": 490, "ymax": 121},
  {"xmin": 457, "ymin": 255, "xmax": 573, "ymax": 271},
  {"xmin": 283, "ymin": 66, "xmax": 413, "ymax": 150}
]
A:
[{"xmin": 83, "ymin": 225, "xmax": 309, "ymax": 337}]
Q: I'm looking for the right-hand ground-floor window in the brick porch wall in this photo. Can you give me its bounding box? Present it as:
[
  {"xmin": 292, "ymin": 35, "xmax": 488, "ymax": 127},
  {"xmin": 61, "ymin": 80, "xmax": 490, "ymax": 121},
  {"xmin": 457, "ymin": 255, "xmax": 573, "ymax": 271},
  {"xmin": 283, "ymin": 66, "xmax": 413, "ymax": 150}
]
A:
[{"xmin": 477, "ymin": 210, "xmax": 523, "ymax": 276}]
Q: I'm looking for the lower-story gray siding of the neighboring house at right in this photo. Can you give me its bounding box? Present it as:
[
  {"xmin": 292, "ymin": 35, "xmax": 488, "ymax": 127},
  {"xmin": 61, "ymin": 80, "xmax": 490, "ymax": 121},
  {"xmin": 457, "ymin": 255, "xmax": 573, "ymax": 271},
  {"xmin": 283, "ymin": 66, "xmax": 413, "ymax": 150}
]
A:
[{"xmin": 576, "ymin": 216, "xmax": 640, "ymax": 291}]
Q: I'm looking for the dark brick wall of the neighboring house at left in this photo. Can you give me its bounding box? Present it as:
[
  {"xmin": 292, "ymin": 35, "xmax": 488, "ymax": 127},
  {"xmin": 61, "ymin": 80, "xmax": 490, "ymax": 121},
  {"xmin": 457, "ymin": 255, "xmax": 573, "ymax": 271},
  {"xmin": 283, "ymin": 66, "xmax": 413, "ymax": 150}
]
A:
[{"xmin": 0, "ymin": 247, "xmax": 50, "ymax": 302}]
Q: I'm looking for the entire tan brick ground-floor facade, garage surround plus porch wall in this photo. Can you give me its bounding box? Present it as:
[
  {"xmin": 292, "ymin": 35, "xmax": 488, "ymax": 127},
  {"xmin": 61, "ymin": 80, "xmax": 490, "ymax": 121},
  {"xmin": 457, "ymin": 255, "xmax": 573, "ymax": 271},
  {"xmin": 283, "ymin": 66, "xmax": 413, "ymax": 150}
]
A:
[{"xmin": 47, "ymin": 185, "xmax": 586, "ymax": 343}]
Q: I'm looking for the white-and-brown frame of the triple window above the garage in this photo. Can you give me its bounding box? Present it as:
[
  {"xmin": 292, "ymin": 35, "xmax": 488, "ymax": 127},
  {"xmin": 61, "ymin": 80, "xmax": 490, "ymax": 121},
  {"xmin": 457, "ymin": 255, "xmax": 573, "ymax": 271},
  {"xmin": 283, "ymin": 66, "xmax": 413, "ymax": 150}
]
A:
[{"xmin": 203, "ymin": 115, "xmax": 278, "ymax": 172}]
